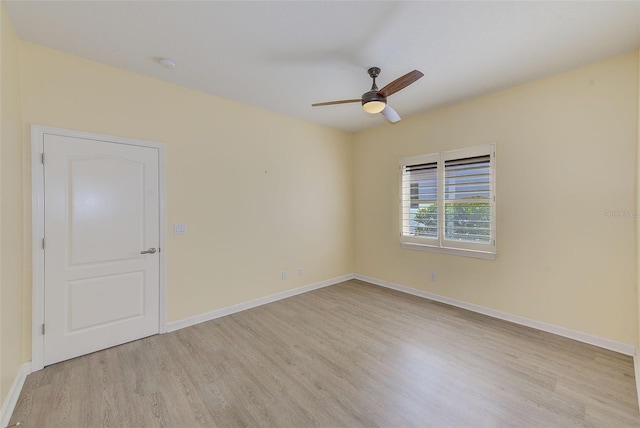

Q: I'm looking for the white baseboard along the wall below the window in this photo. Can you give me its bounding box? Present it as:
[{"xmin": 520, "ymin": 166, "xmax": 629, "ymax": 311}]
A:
[{"xmin": 354, "ymin": 274, "xmax": 638, "ymax": 356}]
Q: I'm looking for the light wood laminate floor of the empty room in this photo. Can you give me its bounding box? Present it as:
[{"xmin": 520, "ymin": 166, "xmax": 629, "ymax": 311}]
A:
[{"xmin": 11, "ymin": 280, "xmax": 640, "ymax": 427}]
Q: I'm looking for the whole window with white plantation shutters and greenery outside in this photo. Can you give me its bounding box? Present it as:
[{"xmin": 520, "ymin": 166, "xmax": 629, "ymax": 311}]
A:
[{"xmin": 400, "ymin": 144, "xmax": 496, "ymax": 259}]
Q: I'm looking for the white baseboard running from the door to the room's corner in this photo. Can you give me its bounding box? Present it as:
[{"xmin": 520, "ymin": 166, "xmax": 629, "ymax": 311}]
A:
[{"xmin": 166, "ymin": 274, "xmax": 354, "ymax": 333}]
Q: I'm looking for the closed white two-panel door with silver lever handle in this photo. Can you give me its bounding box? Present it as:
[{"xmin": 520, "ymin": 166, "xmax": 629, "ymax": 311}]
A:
[{"xmin": 43, "ymin": 134, "xmax": 160, "ymax": 365}]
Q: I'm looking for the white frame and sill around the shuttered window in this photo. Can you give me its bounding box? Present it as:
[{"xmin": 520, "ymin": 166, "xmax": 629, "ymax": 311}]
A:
[{"xmin": 400, "ymin": 144, "xmax": 497, "ymax": 260}]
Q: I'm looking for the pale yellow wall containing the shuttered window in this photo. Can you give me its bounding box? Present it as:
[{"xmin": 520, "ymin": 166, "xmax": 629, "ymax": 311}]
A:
[{"xmin": 354, "ymin": 52, "xmax": 638, "ymax": 344}]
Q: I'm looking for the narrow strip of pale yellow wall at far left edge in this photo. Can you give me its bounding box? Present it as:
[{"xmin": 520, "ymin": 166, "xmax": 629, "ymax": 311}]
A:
[{"xmin": 0, "ymin": 0, "xmax": 24, "ymax": 403}]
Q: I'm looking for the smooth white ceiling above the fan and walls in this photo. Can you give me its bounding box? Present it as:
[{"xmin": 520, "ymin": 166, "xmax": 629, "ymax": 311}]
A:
[{"xmin": 5, "ymin": 0, "xmax": 640, "ymax": 131}]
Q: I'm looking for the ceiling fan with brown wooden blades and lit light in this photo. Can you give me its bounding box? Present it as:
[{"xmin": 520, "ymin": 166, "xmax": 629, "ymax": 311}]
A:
[{"xmin": 311, "ymin": 67, "xmax": 424, "ymax": 123}]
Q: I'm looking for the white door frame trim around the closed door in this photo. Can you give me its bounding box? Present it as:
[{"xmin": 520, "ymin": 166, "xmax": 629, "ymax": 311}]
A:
[{"xmin": 31, "ymin": 125, "xmax": 167, "ymax": 371}]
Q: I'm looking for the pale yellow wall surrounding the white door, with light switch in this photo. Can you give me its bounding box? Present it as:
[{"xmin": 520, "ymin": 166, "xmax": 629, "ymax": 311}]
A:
[{"xmin": 20, "ymin": 42, "xmax": 354, "ymax": 358}]
